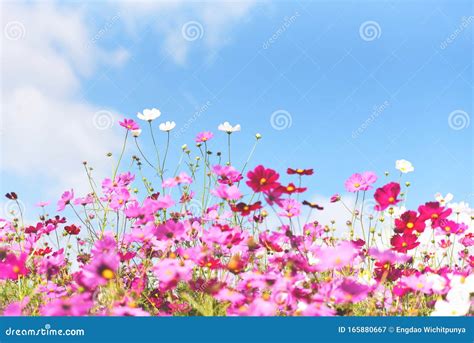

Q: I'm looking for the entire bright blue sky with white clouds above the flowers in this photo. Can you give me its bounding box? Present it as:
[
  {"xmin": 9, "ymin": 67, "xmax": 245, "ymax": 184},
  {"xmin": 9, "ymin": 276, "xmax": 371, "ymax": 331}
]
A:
[{"xmin": 0, "ymin": 1, "xmax": 474, "ymax": 219}]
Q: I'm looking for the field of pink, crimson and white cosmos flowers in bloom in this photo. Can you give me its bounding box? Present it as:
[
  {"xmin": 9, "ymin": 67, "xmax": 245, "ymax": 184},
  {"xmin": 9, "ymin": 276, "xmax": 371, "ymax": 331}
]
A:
[{"xmin": 0, "ymin": 109, "xmax": 474, "ymax": 316}]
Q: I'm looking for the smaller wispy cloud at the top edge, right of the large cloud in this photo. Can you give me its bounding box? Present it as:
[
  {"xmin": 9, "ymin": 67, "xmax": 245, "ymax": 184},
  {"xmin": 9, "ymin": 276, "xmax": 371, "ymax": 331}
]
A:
[{"xmin": 114, "ymin": 0, "xmax": 258, "ymax": 64}]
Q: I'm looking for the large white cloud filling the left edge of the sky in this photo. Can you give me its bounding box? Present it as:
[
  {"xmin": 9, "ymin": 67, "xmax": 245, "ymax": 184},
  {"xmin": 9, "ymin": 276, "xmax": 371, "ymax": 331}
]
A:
[{"xmin": 0, "ymin": 2, "xmax": 127, "ymax": 200}]
